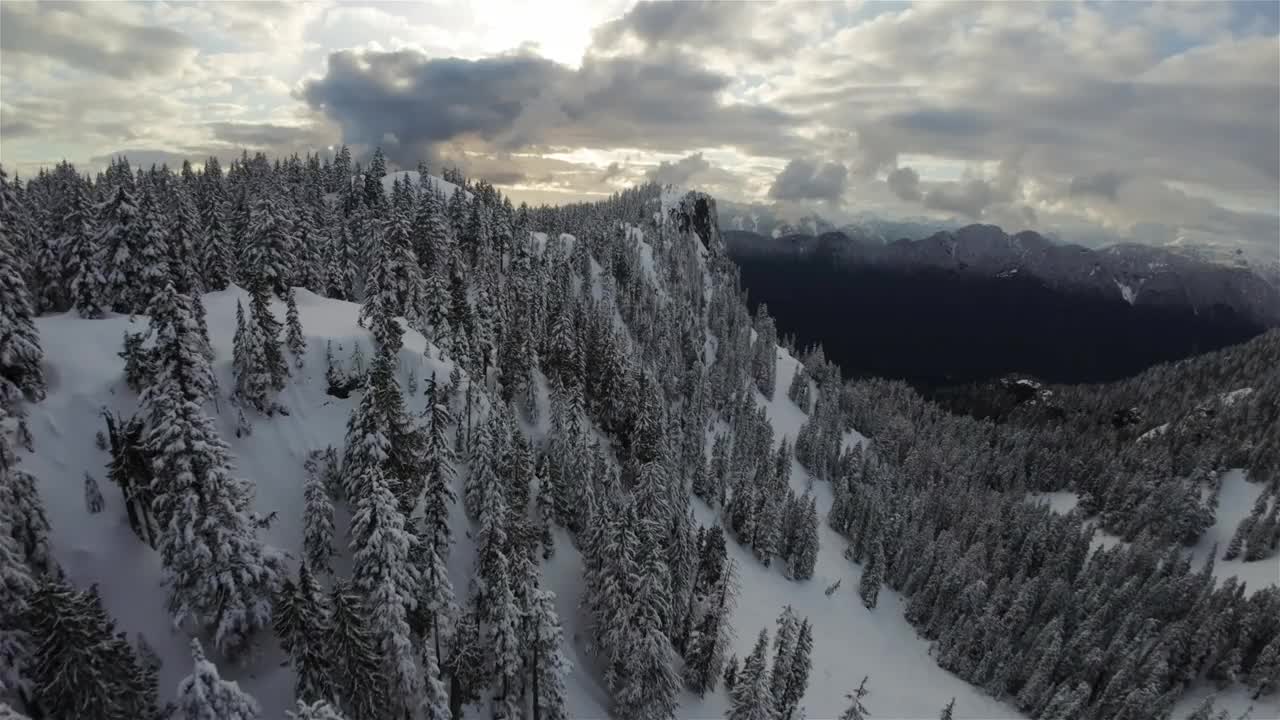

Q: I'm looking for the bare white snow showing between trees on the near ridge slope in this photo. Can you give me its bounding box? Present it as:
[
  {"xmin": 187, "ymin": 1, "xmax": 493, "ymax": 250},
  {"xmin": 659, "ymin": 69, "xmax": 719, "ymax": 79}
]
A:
[{"xmin": 23, "ymin": 288, "xmax": 1039, "ymax": 720}]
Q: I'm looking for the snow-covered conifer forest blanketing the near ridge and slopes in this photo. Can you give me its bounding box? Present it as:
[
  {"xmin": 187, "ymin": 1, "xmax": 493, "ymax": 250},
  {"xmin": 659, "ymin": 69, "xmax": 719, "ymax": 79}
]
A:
[{"xmin": 0, "ymin": 147, "xmax": 1280, "ymax": 720}]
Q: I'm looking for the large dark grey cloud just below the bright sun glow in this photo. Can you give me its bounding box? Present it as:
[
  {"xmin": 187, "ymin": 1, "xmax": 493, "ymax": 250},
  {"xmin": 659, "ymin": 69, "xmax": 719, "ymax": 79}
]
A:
[{"xmin": 302, "ymin": 50, "xmax": 791, "ymax": 161}]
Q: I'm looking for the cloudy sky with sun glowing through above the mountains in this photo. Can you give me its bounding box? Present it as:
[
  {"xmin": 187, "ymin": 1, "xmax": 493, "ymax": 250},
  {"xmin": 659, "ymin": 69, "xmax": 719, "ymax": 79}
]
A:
[{"xmin": 0, "ymin": 0, "xmax": 1280, "ymax": 260}]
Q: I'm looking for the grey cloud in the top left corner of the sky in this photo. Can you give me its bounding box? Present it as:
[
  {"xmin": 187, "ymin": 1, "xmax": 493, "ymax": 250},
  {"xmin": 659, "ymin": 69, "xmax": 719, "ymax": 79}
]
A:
[{"xmin": 0, "ymin": 3, "xmax": 195, "ymax": 78}]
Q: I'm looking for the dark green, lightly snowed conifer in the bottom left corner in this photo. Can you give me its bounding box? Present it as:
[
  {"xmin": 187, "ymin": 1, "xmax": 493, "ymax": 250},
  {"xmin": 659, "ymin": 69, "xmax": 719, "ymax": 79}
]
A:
[{"xmin": 26, "ymin": 579, "xmax": 156, "ymax": 720}]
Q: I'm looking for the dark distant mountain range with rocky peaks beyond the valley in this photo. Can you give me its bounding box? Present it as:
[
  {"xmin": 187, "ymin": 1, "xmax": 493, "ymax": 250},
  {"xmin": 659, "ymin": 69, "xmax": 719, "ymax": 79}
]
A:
[{"xmin": 724, "ymin": 224, "xmax": 1280, "ymax": 386}]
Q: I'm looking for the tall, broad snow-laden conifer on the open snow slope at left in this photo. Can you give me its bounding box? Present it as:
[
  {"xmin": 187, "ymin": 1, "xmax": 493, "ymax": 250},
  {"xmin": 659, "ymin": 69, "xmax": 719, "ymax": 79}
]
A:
[{"xmin": 141, "ymin": 284, "xmax": 280, "ymax": 655}]
